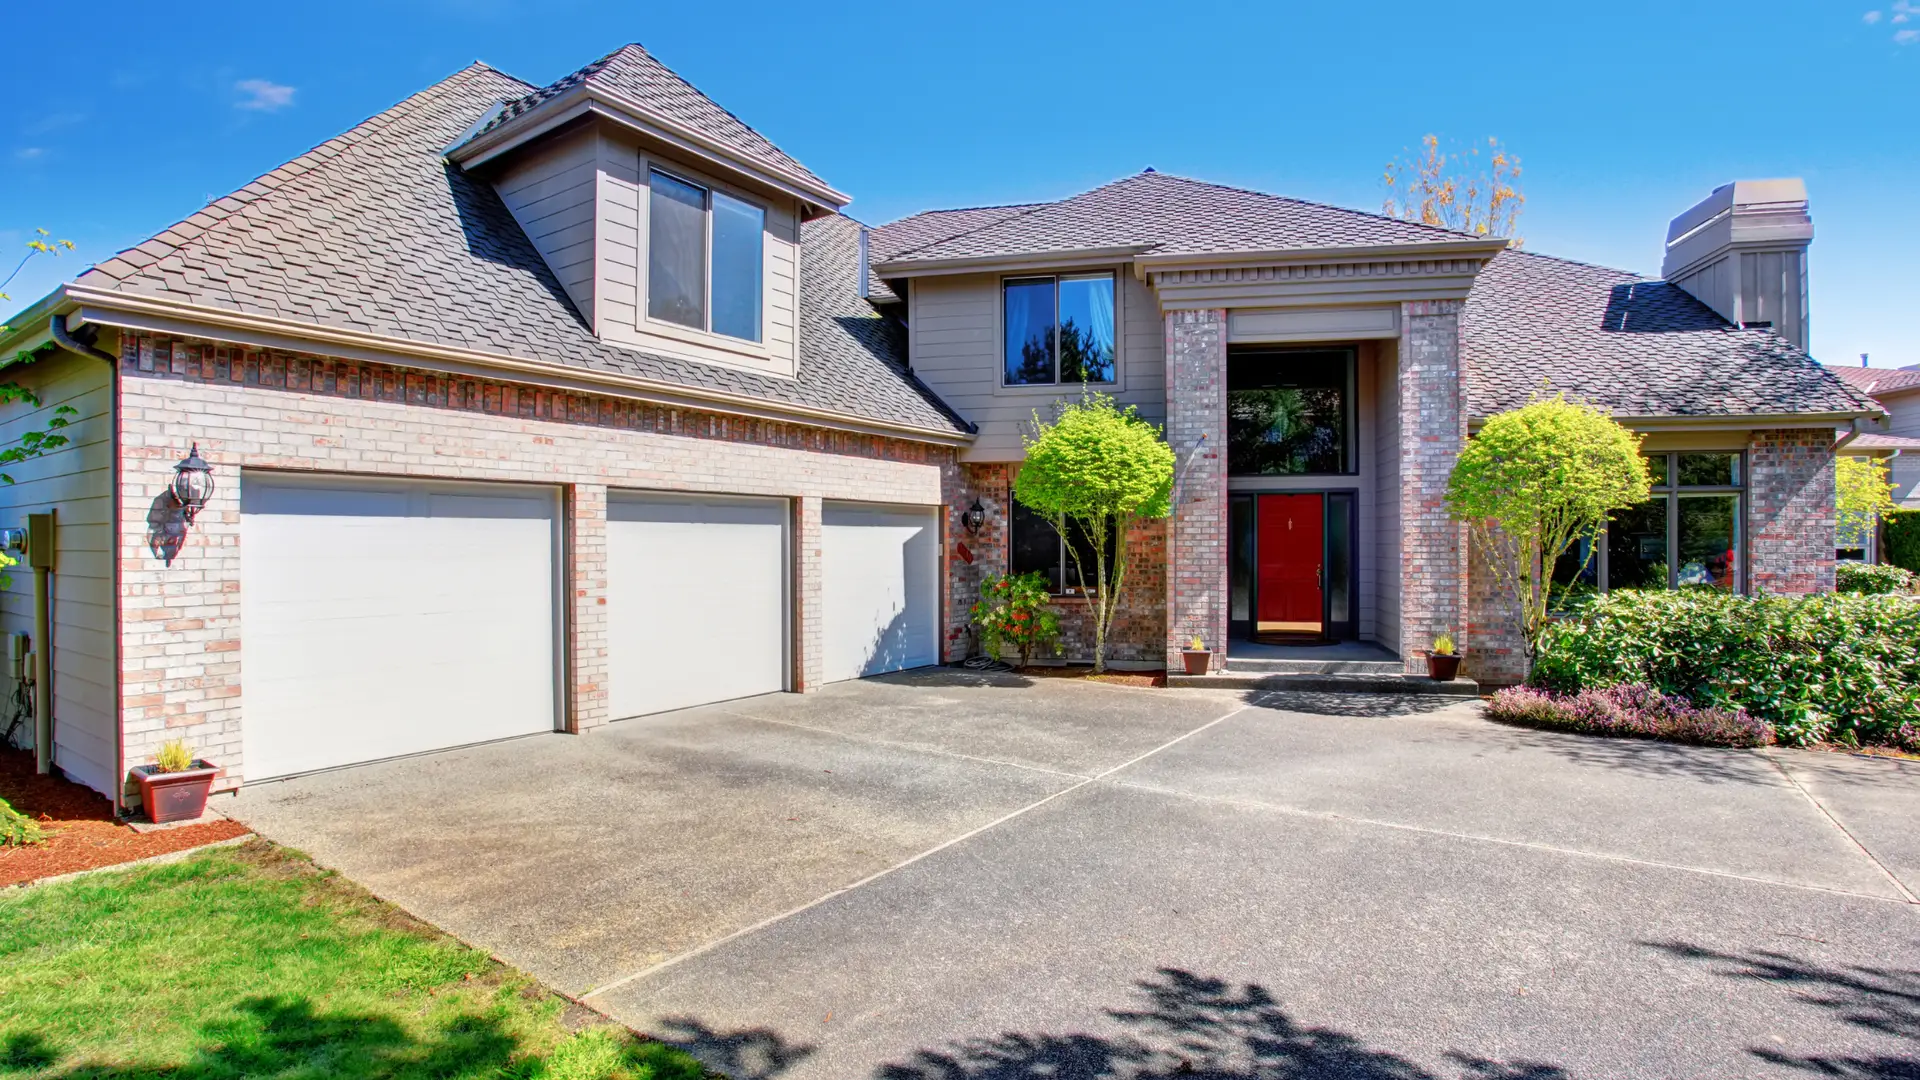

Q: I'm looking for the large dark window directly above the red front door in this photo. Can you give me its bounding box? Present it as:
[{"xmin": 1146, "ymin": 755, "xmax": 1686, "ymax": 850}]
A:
[{"xmin": 1227, "ymin": 348, "xmax": 1357, "ymax": 477}]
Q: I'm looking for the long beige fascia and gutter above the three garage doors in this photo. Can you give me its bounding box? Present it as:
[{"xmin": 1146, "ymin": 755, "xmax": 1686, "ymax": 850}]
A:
[{"xmin": 69, "ymin": 286, "xmax": 973, "ymax": 446}]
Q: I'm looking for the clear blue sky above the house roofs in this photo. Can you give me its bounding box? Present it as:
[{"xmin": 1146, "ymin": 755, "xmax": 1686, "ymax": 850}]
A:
[{"xmin": 0, "ymin": 0, "xmax": 1920, "ymax": 367}]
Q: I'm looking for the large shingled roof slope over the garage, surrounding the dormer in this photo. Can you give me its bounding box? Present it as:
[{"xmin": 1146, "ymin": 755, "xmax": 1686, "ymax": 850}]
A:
[{"xmin": 77, "ymin": 63, "xmax": 966, "ymax": 434}]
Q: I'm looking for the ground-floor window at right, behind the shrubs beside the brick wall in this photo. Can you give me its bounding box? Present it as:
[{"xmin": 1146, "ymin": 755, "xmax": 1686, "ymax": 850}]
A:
[{"xmin": 1553, "ymin": 452, "xmax": 1745, "ymax": 592}]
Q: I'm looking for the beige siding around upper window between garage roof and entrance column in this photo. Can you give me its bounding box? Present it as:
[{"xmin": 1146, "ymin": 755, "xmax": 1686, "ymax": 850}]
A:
[{"xmin": 908, "ymin": 267, "xmax": 1167, "ymax": 461}]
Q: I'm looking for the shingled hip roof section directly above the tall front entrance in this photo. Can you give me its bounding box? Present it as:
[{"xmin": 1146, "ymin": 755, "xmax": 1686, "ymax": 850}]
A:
[{"xmin": 876, "ymin": 171, "xmax": 1482, "ymax": 263}]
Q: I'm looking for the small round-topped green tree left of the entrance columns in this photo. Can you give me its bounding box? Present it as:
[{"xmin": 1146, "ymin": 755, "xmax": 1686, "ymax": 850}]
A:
[{"xmin": 1014, "ymin": 394, "xmax": 1173, "ymax": 671}]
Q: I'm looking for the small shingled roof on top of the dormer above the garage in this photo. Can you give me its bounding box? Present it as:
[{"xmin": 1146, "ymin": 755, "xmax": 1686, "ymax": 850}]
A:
[{"xmin": 468, "ymin": 44, "xmax": 831, "ymax": 188}]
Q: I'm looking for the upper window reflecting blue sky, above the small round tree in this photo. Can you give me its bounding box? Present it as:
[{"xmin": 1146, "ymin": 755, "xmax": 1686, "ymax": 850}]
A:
[{"xmin": 1000, "ymin": 273, "xmax": 1114, "ymax": 386}]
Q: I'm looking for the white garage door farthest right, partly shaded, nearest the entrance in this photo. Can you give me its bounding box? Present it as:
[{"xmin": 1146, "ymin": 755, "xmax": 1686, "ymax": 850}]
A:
[{"xmin": 822, "ymin": 503, "xmax": 941, "ymax": 682}]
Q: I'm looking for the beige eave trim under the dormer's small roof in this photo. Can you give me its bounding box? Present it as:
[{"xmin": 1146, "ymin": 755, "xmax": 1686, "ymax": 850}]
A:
[{"xmin": 447, "ymin": 83, "xmax": 852, "ymax": 211}]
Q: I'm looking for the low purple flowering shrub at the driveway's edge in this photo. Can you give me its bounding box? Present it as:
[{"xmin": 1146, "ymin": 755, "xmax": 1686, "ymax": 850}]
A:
[{"xmin": 1486, "ymin": 682, "xmax": 1774, "ymax": 746}]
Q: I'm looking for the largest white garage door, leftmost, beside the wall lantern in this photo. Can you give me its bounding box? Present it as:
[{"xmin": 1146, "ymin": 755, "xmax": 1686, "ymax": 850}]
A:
[{"xmin": 240, "ymin": 473, "xmax": 559, "ymax": 780}]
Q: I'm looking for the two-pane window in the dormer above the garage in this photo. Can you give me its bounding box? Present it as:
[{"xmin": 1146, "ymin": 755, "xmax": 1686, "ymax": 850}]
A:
[{"xmin": 647, "ymin": 169, "xmax": 766, "ymax": 342}]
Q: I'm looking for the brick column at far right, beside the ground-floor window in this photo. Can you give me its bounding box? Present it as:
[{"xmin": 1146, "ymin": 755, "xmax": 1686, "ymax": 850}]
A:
[{"xmin": 1747, "ymin": 429, "xmax": 1836, "ymax": 596}]
